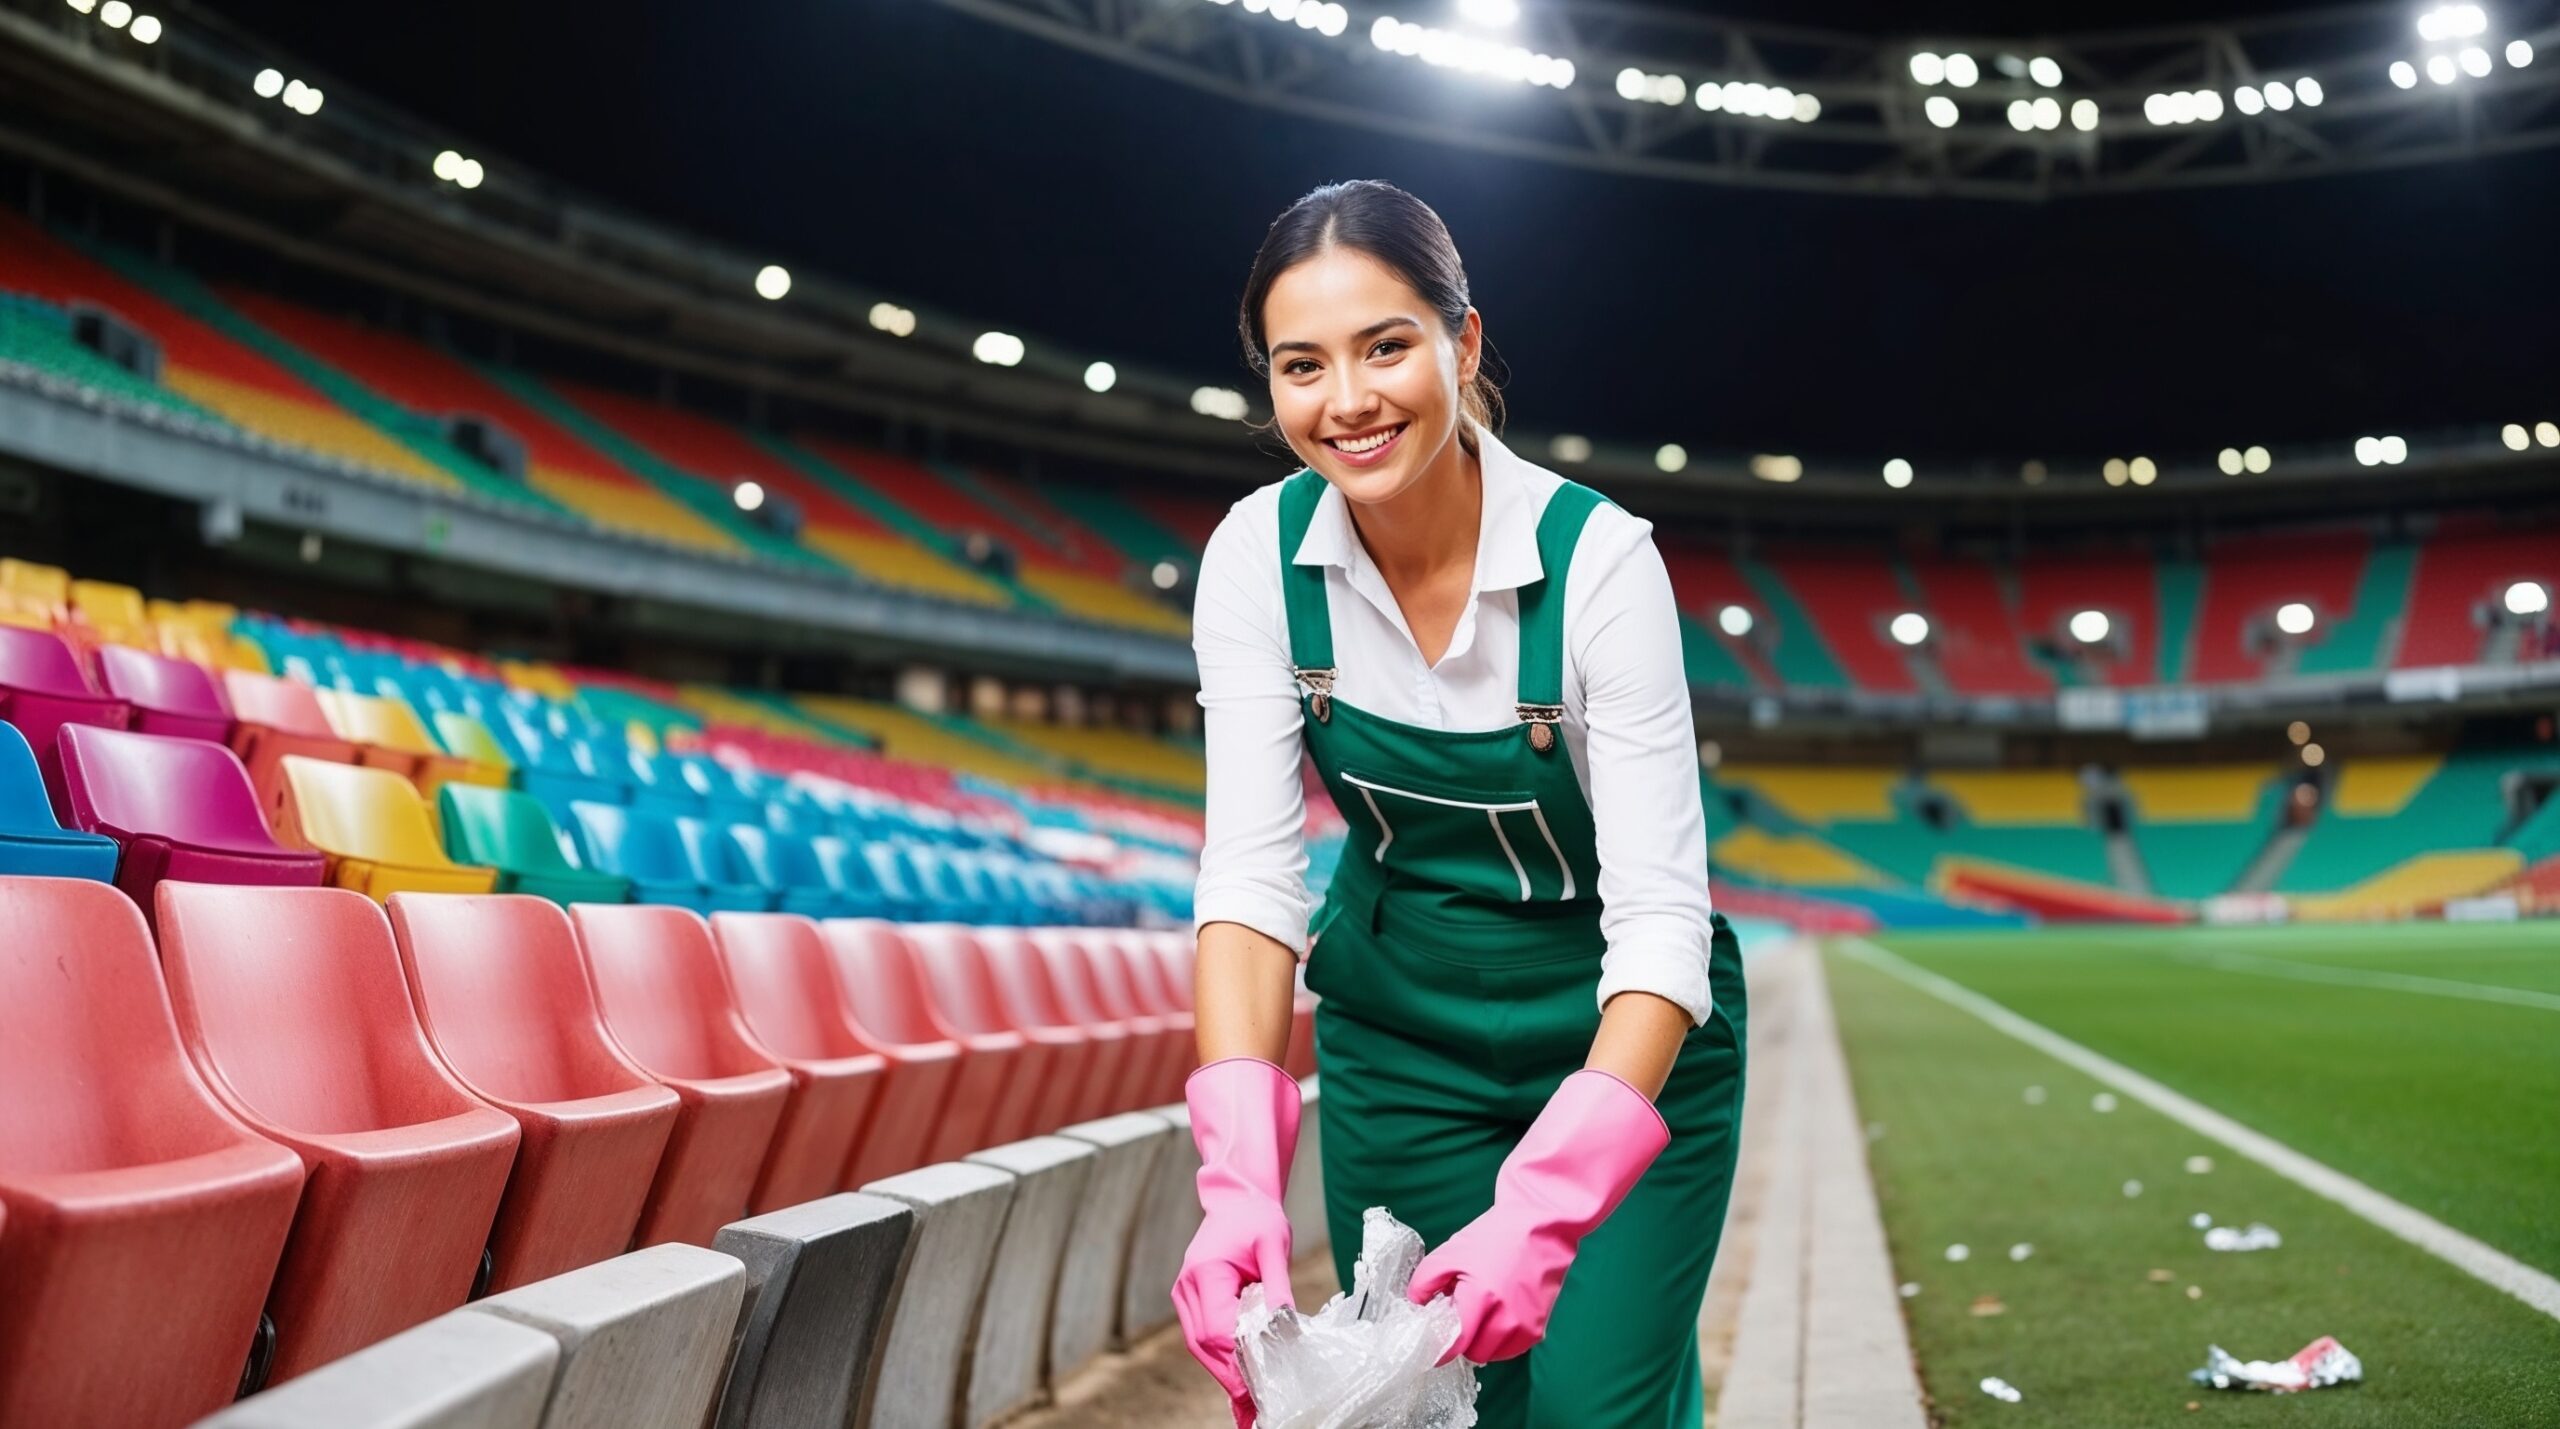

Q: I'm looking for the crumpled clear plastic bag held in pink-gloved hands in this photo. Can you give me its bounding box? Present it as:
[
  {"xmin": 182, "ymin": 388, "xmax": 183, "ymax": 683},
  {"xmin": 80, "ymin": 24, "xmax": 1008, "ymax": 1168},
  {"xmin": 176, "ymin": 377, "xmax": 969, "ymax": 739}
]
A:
[{"xmin": 1236, "ymin": 1206, "xmax": 1475, "ymax": 1429}]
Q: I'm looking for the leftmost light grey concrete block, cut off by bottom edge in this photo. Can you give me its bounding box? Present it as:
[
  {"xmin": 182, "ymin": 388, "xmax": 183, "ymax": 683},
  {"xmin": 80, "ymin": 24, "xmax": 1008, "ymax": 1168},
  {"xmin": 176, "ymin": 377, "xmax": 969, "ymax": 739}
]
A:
[{"xmin": 195, "ymin": 1311, "xmax": 561, "ymax": 1429}]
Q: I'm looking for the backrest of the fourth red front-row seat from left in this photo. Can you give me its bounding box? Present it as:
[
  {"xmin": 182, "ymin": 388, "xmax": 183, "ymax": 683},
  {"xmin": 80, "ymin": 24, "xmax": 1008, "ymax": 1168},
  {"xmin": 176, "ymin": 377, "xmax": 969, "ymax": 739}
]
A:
[{"xmin": 568, "ymin": 904, "xmax": 773, "ymax": 1078}]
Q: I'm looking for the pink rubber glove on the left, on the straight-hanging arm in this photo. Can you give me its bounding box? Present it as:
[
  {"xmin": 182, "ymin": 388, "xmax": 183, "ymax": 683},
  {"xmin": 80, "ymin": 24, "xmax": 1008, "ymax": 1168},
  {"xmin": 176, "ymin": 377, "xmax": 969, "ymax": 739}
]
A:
[{"xmin": 1172, "ymin": 1058, "xmax": 1300, "ymax": 1429}]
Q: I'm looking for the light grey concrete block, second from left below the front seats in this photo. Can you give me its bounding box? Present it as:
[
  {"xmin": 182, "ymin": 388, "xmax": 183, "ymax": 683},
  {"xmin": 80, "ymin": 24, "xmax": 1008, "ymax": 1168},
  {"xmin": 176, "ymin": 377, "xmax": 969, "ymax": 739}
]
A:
[{"xmin": 453, "ymin": 1245, "xmax": 748, "ymax": 1429}]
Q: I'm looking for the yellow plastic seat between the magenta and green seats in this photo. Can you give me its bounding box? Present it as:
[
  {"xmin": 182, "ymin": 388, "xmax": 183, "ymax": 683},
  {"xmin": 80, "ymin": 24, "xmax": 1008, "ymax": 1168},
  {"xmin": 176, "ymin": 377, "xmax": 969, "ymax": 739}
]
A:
[{"xmin": 274, "ymin": 755, "xmax": 497, "ymax": 901}]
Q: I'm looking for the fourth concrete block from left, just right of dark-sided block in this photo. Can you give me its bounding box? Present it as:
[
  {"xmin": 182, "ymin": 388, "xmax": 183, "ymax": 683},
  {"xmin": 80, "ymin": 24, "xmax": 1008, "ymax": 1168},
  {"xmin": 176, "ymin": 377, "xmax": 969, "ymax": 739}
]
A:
[{"xmin": 855, "ymin": 1163, "xmax": 1014, "ymax": 1429}]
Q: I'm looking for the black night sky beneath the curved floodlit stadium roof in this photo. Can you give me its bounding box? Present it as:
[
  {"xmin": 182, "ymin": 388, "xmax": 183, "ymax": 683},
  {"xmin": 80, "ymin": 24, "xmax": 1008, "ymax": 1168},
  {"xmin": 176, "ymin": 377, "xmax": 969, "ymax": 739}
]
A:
[{"xmin": 218, "ymin": 0, "xmax": 2560, "ymax": 458}]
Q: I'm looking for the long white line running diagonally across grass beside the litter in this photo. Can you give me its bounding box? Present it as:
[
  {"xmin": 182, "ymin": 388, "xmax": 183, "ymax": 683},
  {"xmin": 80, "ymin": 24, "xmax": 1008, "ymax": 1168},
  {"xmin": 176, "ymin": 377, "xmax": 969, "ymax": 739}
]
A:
[{"xmin": 1830, "ymin": 937, "xmax": 2560, "ymax": 1319}]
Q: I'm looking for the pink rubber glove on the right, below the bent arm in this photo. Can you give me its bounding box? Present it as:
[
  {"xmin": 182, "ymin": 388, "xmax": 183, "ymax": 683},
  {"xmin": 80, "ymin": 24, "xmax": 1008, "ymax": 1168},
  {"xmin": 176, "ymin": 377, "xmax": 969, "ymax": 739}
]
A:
[{"xmin": 1411, "ymin": 1070, "xmax": 1672, "ymax": 1365}]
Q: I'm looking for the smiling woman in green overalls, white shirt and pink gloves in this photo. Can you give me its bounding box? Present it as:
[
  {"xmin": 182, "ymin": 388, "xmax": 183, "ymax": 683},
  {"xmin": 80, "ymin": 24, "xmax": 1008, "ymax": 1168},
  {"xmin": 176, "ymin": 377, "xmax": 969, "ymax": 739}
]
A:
[{"xmin": 1175, "ymin": 182, "xmax": 1746, "ymax": 1429}]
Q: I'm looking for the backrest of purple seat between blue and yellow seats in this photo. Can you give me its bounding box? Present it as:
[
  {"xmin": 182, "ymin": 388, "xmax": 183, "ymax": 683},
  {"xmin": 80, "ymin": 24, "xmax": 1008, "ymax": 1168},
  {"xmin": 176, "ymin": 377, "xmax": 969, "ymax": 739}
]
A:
[{"xmin": 59, "ymin": 725, "xmax": 279, "ymax": 853}]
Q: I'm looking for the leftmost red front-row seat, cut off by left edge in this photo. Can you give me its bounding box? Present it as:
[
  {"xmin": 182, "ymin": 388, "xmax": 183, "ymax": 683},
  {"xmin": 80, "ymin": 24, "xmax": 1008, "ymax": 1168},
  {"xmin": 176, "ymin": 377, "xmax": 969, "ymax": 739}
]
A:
[{"xmin": 0, "ymin": 878, "xmax": 302, "ymax": 1429}]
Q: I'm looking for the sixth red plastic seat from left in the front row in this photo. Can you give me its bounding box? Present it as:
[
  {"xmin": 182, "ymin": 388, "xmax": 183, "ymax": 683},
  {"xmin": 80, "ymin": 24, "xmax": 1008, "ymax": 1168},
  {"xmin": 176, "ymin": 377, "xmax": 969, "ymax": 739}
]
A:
[{"xmin": 824, "ymin": 917, "xmax": 1006, "ymax": 1186}]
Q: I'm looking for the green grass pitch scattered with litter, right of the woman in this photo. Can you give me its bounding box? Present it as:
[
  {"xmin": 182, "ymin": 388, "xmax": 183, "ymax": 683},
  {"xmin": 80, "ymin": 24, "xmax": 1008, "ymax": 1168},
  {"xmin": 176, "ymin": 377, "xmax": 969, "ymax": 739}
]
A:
[{"xmin": 1825, "ymin": 924, "xmax": 2560, "ymax": 1426}]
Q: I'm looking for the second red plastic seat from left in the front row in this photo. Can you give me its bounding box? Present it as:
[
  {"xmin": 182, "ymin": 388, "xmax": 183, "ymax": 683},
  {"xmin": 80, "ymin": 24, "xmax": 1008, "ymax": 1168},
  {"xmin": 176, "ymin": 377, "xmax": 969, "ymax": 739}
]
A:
[{"xmin": 159, "ymin": 884, "xmax": 517, "ymax": 1380}]
